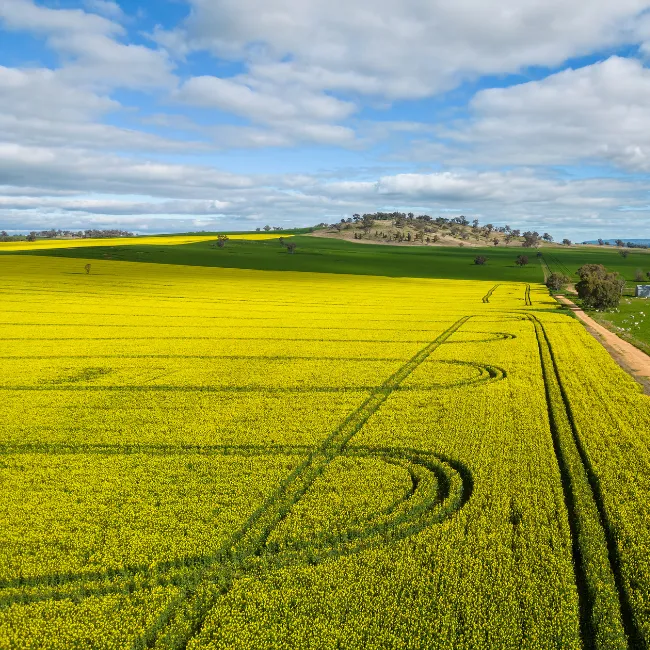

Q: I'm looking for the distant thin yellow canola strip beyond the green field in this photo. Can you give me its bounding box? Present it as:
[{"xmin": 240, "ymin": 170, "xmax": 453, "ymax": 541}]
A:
[{"xmin": 0, "ymin": 232, "xmax": 286, "ymax": 253}]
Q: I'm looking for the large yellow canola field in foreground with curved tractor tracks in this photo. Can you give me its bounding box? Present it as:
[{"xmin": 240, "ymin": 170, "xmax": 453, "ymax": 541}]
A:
[{"xmin": 0, "ymin": 254, "xmax": 650, "ymax": 650}]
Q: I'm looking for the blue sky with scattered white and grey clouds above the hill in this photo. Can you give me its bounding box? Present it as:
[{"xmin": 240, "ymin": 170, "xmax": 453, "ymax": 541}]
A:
[{"xmin": 0, "ymin": 0, "xmax": 650, "ymax": 240}]
